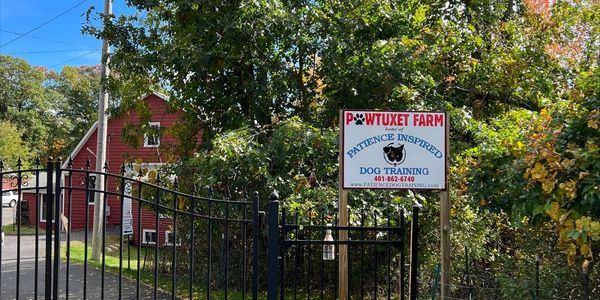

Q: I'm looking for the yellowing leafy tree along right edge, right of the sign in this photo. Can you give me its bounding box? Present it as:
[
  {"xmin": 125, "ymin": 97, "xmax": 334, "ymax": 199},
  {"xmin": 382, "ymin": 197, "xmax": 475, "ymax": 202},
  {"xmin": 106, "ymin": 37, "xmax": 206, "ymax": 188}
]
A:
[{"xmin": 459, "ymin": 0, "xmax": 600, "ymax": 265}]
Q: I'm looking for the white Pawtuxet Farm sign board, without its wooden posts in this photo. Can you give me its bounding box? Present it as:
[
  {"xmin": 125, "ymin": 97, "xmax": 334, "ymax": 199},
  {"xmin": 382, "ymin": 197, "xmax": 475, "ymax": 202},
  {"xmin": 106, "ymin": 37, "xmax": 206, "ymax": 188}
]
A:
[{"xmin": 341, "ymin": 110, "xmax": 448, "ymax": 190}]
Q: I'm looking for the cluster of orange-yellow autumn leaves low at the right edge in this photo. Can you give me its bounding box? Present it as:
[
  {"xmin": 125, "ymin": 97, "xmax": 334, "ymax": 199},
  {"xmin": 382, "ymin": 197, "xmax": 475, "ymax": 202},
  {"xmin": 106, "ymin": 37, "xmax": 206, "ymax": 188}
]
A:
[{"xmin": 524, "ymin": 110, "xmax": 600, "ymax": 264}]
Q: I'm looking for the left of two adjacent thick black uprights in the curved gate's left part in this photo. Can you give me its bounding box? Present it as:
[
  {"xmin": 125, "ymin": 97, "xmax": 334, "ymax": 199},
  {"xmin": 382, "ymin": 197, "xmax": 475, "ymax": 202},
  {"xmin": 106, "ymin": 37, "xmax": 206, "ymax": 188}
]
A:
[{"xmin": 43, "ymin": 158, "xmax": 54, "ymax": 300}]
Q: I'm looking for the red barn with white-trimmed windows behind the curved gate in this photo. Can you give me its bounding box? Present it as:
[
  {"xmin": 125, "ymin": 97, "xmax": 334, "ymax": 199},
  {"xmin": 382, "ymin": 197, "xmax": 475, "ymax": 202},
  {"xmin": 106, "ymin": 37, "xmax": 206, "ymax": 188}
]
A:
[{"xmin": 23, "ymin": 93, "xmax": 201, "ymax": 245}]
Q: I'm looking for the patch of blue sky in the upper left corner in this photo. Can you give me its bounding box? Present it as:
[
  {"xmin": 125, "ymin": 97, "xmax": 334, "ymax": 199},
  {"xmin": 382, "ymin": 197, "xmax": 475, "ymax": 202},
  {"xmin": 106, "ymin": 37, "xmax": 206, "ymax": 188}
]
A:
[{"xmin": 0, "ymin": 0, "xmax": 132, "ymax": 71}]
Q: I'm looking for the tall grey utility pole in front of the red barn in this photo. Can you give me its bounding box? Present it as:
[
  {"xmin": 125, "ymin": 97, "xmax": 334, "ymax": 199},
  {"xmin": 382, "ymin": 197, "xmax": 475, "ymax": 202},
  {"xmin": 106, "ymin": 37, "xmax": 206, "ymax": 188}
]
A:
[{"xmin": 91, "ymin": 0, "xmax": 112, "ymax": 261}]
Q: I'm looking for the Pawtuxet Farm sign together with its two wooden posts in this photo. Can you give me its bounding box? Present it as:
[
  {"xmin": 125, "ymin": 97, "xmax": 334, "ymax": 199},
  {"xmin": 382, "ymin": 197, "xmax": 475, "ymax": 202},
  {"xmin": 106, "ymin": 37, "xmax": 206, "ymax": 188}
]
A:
[{"xmin": 338, "ymin": 110, "xmax": 450, "ymax": 300}]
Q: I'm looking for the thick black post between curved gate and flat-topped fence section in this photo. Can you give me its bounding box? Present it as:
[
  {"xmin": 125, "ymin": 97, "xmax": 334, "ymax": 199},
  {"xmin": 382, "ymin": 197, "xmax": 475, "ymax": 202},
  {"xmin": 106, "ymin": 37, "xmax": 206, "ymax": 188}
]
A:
[{"xmin": 267, "ymin": 192, "xmax": 279, "ymax": 300}]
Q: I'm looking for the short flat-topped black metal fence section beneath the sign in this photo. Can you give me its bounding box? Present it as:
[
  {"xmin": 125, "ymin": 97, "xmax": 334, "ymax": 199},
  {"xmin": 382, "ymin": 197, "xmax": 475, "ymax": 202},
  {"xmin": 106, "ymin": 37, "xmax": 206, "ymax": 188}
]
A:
[{"xmin": 267, "ymin": 193, "xmax": 406, "ymax": 300}]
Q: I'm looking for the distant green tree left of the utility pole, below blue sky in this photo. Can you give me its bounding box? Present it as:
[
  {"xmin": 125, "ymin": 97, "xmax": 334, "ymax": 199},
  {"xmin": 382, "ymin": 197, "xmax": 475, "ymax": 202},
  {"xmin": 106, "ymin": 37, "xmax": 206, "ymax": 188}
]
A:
[{"xmin": 0, "ymin": 55, "xmax": 100, "ymax": 161}]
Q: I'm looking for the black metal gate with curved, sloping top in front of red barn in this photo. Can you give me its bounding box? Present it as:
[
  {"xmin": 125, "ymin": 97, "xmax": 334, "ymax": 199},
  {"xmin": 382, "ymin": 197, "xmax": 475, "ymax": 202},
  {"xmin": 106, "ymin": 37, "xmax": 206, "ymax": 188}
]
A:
[{"xmin": 0, "ymin": 160, "xmax": 260, "ymax": 299}]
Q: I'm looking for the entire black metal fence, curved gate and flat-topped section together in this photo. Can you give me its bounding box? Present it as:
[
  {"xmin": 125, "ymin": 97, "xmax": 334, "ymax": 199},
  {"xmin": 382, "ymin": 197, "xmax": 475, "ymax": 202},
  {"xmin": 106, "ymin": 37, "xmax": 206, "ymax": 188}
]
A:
[{"xmin": 0, "ymin": 160, "xmax": 418, "ymax": 299}]
